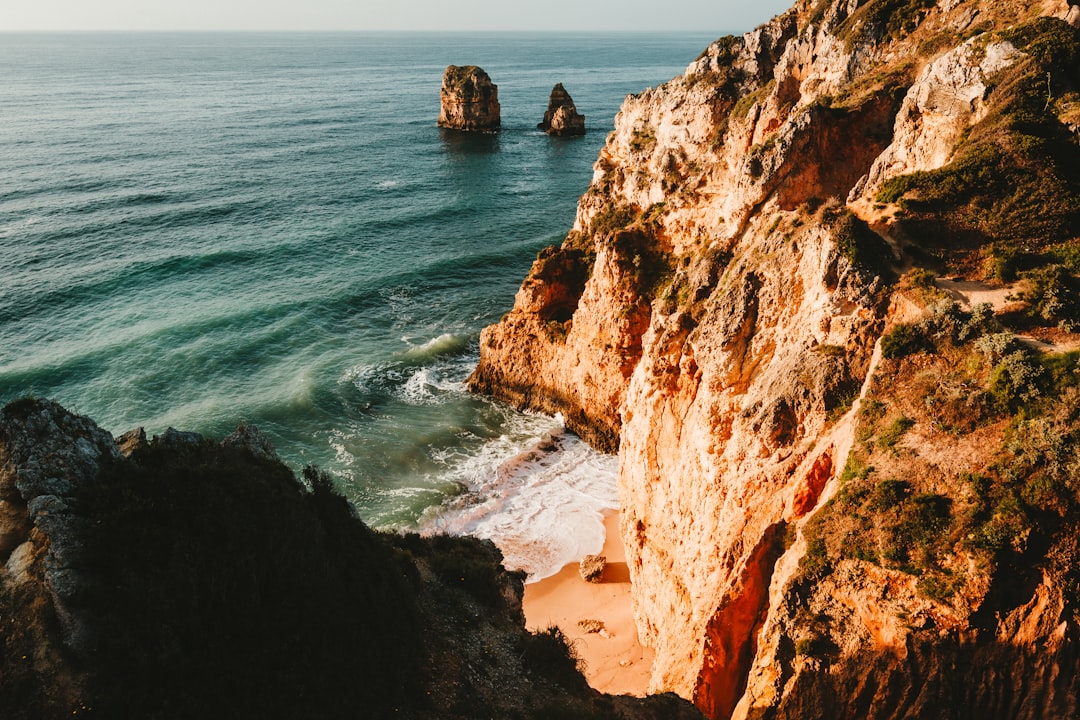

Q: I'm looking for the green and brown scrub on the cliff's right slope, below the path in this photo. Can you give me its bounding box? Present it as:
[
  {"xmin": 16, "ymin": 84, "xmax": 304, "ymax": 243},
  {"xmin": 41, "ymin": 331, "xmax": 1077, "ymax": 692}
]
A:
[{"xmin": 802, "ymin": 301, "xmax": 1080, "ymax": 614}]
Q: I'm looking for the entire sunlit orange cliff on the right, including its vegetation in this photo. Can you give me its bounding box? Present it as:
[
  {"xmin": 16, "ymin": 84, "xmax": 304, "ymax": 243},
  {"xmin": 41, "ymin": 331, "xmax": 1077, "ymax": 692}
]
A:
[{"xmin": 472, "ymin": 0, "xmax": 1080, "ymax": 718}]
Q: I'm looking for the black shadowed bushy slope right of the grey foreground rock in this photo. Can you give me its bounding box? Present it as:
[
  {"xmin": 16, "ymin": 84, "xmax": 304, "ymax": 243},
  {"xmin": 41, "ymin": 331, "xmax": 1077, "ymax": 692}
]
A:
[{"xmin": 81, "ymin": 443, "xmax": 420, "ymax": 718}]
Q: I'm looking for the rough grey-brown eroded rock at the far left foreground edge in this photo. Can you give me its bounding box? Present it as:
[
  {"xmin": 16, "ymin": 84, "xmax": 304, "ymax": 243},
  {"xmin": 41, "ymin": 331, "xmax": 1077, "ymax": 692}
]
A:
[{"xmin": 0, "ymin": 400, "xmax": 120, "ymax": 717}]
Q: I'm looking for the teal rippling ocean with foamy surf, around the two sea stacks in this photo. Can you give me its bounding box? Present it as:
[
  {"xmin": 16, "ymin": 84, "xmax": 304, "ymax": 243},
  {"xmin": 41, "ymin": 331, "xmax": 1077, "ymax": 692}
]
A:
[{"xmin": 0, "ymin": 32, "xmax": 723, "ymax": 580}]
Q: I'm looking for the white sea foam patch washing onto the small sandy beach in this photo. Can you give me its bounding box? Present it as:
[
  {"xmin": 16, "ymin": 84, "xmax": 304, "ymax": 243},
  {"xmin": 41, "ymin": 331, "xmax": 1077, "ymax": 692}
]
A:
[{"xmin": 423, "ymin": 420, "xmax": 618, "ymax": 582}]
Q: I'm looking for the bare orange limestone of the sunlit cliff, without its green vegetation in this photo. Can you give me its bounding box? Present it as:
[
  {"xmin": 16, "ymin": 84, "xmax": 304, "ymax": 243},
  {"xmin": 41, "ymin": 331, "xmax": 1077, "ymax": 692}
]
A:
[{"xmin": 472, "ymin": 0, "xmax": 1080, "ymax": 718}]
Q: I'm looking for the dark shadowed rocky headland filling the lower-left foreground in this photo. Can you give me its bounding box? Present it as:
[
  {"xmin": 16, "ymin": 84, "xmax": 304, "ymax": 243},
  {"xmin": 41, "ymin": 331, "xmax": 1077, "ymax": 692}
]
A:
[{"xmin": 0, "ymin": 399, "xmax": 700, "ymax": 720}]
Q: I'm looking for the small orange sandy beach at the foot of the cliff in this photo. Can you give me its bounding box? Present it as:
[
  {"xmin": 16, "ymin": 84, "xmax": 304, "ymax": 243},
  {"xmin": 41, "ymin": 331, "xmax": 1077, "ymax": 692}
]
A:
[{"xmin": 524, "ymin": 512, "xmax": 653, "ymax": 696}]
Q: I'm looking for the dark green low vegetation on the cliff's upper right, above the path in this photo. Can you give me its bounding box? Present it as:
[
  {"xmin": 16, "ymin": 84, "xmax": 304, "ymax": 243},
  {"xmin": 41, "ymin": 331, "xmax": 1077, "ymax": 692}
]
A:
[{"xmin": 877, "ymin": 17, "xmax": 1080, "ymax": 262}]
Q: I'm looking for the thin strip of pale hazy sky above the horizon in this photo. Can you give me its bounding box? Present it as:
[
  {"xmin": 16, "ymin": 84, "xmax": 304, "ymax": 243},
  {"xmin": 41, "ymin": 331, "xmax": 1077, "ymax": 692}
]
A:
[{"xmin": 0, "ymin": 0, "xmax": 794, "ymax": 33}]
